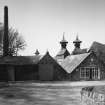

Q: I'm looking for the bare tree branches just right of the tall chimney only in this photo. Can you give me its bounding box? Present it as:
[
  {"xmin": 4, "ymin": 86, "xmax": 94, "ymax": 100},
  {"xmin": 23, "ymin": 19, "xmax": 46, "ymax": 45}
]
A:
[{"xmin": 8, "ymin": 28, "xmax": 26, "ymax": 56}]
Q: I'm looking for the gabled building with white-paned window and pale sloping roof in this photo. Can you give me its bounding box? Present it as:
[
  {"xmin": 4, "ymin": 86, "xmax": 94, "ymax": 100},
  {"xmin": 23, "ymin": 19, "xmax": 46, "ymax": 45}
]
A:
[{"xmin": 61, "ymin": 52, "xmax": 105, "ymax": 81}]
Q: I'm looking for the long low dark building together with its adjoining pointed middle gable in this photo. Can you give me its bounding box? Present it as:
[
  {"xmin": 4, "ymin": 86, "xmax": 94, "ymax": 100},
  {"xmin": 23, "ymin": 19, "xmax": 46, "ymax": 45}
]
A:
[{"xmin": 0, "ymin": 52, "xmax": 67, "ymax": 81}]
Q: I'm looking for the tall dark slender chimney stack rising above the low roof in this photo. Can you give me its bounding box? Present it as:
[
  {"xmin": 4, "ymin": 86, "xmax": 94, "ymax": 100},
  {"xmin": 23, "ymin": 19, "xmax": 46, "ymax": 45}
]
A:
[{"xmin": 3, "ymin": 6, "xmax": 9, "ymax": 56}]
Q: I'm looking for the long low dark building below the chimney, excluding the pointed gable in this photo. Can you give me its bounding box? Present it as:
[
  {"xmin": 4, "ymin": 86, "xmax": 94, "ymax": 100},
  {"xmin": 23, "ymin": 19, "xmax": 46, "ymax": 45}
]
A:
[{"xmin": 0, "ymin": 56, "xmax": 40, "ymax": 81}]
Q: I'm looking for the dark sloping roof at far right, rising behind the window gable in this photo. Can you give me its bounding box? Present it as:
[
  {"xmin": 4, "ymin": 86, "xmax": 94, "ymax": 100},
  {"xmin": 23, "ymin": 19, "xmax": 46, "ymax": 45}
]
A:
[{"xmin": 89, "ymin": 42, "xmax": 105, "ymax": 63}]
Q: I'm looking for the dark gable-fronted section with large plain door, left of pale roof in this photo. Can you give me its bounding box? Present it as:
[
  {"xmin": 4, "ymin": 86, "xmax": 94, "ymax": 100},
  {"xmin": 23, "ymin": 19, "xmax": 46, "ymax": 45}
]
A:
[{"xmin": 38, "ymin": 52, "xmax": 68, "ymax": 81}]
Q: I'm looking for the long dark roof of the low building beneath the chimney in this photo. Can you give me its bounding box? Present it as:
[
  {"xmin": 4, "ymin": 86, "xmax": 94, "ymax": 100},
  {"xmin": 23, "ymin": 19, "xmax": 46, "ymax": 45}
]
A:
[{"xmin": 0, "ymin": 56, "xmax": 42, "ymax": 65}]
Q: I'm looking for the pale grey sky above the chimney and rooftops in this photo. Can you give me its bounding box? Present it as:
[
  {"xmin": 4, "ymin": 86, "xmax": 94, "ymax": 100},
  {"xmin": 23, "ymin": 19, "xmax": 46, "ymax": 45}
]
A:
[{"xmin": 0, "ymin": 0, "xmax": 105, "ymax": 56}]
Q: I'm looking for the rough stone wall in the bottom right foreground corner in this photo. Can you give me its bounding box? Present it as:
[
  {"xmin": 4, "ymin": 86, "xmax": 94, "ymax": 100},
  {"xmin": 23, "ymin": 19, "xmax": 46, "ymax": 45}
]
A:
[{"xmin": 81, "ymin": 87, "xmax": 105, "ymax": 105}]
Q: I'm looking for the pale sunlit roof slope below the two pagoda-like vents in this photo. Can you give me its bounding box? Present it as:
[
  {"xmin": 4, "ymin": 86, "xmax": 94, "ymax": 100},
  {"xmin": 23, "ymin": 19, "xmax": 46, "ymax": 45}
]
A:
[{"xmin": 61, "ymin": 53, "xmax": 90, "ymax": 73}]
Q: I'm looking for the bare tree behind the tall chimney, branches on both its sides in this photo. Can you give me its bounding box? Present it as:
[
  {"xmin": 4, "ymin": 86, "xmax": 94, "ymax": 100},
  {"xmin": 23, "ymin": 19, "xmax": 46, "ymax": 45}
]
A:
[{"xmin": 0, "ymin": 24, "xmax": 26, "ymax": 56}]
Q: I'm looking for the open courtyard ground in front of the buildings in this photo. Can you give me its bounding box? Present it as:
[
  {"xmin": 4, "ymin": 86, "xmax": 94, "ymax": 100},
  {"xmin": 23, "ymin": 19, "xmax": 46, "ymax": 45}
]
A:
[{"xmin": 0, "ymin": 81, "xmax": 105, "ymax": 105}]
